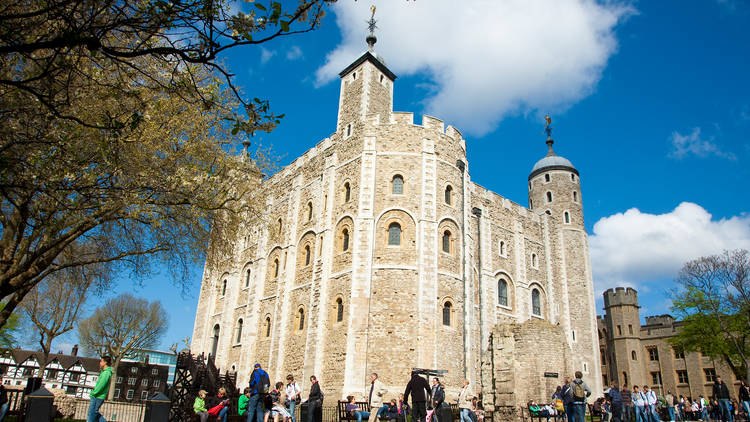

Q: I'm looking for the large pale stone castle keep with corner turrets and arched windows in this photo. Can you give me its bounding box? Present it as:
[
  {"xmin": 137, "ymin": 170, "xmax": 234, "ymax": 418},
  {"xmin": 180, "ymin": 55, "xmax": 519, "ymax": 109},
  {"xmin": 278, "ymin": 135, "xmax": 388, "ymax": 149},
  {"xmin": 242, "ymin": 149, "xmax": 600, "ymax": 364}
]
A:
[{"xmin": 192, "ymin": 31, "xmax": 602, "ymax": 414}]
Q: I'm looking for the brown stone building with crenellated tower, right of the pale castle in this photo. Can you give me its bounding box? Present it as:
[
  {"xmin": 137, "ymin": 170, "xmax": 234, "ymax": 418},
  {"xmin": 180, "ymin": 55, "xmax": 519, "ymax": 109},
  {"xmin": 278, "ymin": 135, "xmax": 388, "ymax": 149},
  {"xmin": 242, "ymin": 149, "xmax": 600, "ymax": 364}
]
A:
[{"xmin": 597, "ymin": 287, "xmax": 740, "ymax": 398}]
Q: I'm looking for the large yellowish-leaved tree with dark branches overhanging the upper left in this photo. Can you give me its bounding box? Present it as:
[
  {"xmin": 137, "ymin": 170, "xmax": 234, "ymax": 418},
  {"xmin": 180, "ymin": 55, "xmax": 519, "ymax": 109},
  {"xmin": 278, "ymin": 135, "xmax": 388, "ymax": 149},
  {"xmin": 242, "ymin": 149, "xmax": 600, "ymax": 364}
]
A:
[{"xmin": 0, "ymin": 0, "xmax": 329, "ymax": 327}]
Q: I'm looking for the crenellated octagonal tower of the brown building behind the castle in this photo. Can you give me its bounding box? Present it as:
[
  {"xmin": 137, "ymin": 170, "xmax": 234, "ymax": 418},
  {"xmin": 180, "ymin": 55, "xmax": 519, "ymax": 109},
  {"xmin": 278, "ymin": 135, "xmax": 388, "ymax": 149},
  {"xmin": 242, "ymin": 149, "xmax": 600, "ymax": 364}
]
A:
[{"xmin": 604, "ymin": 287, "xmax": 646, "ymax": 386}]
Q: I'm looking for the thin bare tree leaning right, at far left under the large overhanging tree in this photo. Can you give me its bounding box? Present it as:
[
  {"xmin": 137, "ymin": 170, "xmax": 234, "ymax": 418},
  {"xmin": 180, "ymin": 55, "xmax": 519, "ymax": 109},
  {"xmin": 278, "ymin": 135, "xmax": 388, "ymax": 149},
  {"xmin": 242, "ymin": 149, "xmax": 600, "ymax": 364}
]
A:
[{"xmin": 20, "ymin": 244, "xmax": 111, "ymax": 377}]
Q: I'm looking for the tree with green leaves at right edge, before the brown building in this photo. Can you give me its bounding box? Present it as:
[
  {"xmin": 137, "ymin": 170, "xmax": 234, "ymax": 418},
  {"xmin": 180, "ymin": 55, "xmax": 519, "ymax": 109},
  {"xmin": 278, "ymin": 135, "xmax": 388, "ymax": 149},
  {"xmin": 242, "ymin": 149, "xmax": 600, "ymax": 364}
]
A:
[{"xmin": 670, "ymin": 249, "xmax": 750, "ymax": 379}]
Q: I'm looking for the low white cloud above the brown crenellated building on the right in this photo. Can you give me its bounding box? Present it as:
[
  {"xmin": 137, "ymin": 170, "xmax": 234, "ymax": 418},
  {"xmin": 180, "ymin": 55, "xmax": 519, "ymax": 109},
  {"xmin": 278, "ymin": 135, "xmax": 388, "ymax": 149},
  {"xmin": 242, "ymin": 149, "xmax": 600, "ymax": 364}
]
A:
[{"xmin": 589, "ymin": 202, "xmax": 750, "ymax": 297}]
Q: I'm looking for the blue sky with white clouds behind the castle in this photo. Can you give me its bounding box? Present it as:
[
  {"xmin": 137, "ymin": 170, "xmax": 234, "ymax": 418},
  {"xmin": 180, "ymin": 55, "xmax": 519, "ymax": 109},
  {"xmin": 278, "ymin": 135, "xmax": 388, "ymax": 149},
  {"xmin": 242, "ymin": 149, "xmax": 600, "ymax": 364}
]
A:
[{"xmin": 55, "ymin": 0, "xmax": 750, "ymax": 349}]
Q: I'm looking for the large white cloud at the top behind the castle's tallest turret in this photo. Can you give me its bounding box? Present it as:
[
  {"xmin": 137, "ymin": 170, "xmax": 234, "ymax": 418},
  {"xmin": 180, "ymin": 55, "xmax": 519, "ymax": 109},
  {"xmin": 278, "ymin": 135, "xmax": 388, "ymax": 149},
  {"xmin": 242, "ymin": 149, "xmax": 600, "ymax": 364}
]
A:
[{"xmin": 316, "ymin": 0, "xmax": 633, "ymax": 135}]
